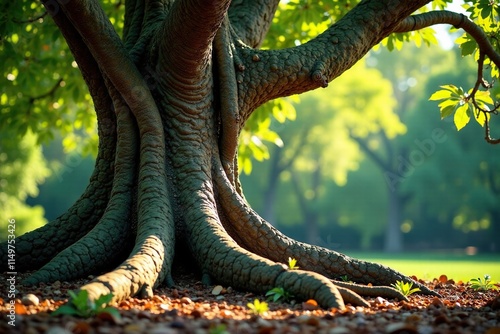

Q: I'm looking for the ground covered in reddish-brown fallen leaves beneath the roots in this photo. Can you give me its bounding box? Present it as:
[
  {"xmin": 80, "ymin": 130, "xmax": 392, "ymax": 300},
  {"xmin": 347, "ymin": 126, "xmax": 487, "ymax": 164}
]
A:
[{"xmin": 0, "ymin": 275, "xmax": 500, "ymax": 334}]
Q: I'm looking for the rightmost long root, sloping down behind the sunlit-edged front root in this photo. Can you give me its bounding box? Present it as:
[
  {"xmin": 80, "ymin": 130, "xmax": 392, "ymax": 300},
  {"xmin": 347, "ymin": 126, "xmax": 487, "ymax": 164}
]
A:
[{"xmin": 213, "ymin": 161, "xmax": 438, "ymax": 299}]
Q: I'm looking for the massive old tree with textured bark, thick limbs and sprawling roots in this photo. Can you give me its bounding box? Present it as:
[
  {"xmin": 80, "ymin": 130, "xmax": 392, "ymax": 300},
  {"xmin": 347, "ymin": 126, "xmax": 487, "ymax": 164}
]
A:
[{"xmin": 0, "ymin": 0, "xmax": 500, "ymax": 308}]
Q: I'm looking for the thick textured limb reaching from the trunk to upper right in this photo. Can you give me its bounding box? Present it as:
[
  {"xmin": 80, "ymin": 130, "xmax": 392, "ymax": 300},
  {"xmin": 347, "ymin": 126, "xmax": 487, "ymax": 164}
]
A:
[{"xmin": 239, "ymin": 0, "xmax": 428, "ymax": 119}]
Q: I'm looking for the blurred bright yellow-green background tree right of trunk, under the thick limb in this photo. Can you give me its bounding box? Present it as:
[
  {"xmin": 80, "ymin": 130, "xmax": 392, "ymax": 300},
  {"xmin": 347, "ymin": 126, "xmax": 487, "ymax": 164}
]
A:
[{"xmin": 242, "ymin": 62, "xmax": 405, "ymax": 244}]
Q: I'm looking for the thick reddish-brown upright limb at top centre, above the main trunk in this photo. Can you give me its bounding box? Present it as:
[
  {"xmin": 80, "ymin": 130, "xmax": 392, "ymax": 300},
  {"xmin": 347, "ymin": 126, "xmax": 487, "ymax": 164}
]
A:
[{"xmin": 159, "ymin": 0, "xmax": 230, "ymax": 82}]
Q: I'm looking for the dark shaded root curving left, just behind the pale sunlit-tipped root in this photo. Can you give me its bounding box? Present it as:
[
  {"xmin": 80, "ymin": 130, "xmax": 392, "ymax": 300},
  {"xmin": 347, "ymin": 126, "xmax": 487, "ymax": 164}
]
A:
[{"xmin": 23, "ymin": 92, "xmax": 138, "ymax": 285}]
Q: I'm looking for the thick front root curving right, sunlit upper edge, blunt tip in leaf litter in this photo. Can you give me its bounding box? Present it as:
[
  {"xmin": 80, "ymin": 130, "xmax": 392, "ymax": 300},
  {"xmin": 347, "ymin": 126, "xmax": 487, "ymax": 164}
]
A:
[{"xmin": 175, "ymin": 166, "xmax": 344, "ymax": 308}]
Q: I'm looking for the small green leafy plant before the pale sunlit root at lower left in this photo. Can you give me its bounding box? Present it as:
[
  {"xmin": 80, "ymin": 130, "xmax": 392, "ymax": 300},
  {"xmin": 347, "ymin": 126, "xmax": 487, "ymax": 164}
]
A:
[{"xmin": 52, "ymin": 290, "xmax": 120, "ymax": 320}]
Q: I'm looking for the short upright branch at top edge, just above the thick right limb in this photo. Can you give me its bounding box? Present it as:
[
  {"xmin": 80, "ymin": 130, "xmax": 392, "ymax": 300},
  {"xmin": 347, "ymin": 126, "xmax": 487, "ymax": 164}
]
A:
[{"xmin": 229, "ymin": 0, "xmax": 279, "ymax": 48}]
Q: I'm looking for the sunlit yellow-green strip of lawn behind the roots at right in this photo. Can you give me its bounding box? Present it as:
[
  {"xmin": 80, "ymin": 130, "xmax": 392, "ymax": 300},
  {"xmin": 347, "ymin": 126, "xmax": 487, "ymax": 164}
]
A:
[{"xmin": 345, "ymin": 251, "xmax": 500, "ymax": 282}]
